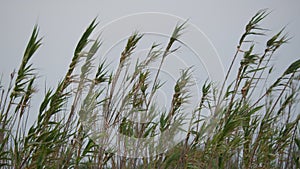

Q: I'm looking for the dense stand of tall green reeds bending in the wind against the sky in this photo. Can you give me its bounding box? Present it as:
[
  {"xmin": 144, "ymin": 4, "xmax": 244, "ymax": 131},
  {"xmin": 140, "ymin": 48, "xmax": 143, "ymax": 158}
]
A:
[{"xmin": 0, "ymin": 10, "xmax": 300, "ymax": 168}]
